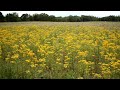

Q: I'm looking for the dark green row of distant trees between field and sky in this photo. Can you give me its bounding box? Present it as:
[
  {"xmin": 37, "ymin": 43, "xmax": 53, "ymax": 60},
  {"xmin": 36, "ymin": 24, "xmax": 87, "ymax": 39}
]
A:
[{"xmin": 0, "ymin": 12, "xmax": 120, "ymax": 22}]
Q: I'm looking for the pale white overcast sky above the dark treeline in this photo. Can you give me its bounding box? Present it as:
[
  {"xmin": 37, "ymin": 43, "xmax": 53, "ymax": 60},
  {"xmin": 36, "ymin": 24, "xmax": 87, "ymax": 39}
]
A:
[{"xmin": 1, "ymin": 11, "xmax": 120, "ymax": 17}]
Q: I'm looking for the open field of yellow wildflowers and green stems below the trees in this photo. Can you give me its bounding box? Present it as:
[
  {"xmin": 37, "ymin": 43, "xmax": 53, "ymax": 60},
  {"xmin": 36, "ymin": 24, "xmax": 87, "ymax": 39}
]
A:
[{"xmin": 0, "ymin": 22, "xmax": 120, "ymax": 79}]
